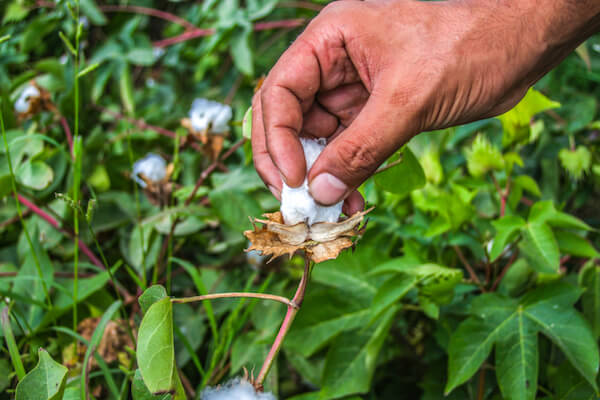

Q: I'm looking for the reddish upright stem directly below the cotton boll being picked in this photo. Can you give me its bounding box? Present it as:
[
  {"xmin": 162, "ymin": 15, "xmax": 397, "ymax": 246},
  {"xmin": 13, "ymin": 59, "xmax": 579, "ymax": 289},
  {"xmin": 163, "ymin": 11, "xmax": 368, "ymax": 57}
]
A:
[{"xmin": 254, "ymin": 255, "xmax": 310, "ymax": 390}]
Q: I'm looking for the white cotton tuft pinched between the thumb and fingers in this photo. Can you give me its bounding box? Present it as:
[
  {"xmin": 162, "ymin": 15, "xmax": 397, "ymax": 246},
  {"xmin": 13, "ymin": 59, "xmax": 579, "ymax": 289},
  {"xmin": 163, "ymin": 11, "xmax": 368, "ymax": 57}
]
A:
[{"xmin": 280, "ymin": 138, "xmax": 344, "ymax": 226}]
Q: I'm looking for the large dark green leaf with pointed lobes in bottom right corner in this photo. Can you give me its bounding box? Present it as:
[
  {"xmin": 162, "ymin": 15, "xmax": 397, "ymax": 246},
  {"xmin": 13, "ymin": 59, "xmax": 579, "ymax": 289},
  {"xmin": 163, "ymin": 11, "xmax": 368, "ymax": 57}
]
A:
[{"xmin": 446, "ymin": 283, "xmax": 599, "ymax": 399}]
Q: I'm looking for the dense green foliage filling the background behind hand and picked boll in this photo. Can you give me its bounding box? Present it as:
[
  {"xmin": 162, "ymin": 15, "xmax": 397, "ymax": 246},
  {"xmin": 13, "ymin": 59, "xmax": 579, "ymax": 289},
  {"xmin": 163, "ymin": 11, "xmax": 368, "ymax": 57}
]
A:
[{"xmin": 0, "ymin": 0, "xmax": 600, "ymax": 400}]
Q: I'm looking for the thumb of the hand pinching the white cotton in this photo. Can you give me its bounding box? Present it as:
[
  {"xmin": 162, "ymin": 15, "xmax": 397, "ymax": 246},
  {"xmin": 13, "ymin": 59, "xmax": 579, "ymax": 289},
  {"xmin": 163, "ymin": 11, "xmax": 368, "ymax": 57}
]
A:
[{"xmin": 308, "ymin": 93, "xmax": 416, "ymax": 205}]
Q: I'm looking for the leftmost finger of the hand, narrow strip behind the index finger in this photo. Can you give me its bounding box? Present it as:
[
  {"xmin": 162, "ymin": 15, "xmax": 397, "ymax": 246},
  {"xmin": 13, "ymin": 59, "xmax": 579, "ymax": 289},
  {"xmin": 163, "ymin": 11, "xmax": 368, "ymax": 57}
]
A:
[{"xmin": 252, "ymin": 92, "xmax": 283, "ymax": 200}]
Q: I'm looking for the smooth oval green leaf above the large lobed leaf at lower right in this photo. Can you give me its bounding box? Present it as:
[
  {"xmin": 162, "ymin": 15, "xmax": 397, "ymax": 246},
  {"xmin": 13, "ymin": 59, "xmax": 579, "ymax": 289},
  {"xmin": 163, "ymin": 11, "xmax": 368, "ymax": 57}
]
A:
[{"xmin": 519, "ymin": 223, "xmax": 560, "ymax": 274}]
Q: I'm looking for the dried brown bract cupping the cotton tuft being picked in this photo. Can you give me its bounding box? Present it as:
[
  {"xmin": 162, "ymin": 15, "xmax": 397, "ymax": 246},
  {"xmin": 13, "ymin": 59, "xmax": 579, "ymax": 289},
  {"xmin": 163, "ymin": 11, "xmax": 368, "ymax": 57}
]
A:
[{"xmin": 244, "ymin": 208, "xmax": 373, "ymax": 263}]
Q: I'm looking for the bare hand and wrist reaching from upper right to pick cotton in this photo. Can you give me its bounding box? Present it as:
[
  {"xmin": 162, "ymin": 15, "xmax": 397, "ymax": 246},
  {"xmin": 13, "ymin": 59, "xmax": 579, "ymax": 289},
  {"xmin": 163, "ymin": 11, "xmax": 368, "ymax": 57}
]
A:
[{"xmin": 252, "ymin": 0, "xmax": 600, "ymax": 214}]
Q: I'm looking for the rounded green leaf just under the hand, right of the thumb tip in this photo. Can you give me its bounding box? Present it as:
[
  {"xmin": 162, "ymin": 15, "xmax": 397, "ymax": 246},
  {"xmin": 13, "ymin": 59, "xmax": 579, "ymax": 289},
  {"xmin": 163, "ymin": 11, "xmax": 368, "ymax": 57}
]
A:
[{"xmin": 374, "ymin": 146, "xmax": 426, "ymax": 195}]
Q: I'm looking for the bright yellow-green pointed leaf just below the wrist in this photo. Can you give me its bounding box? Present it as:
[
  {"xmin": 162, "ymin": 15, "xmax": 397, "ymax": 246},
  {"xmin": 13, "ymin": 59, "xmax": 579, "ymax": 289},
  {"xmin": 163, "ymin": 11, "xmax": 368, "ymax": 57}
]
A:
[{"xmin": 498, "ymin": 88, "xmax": 560, "ymax": 146}]
